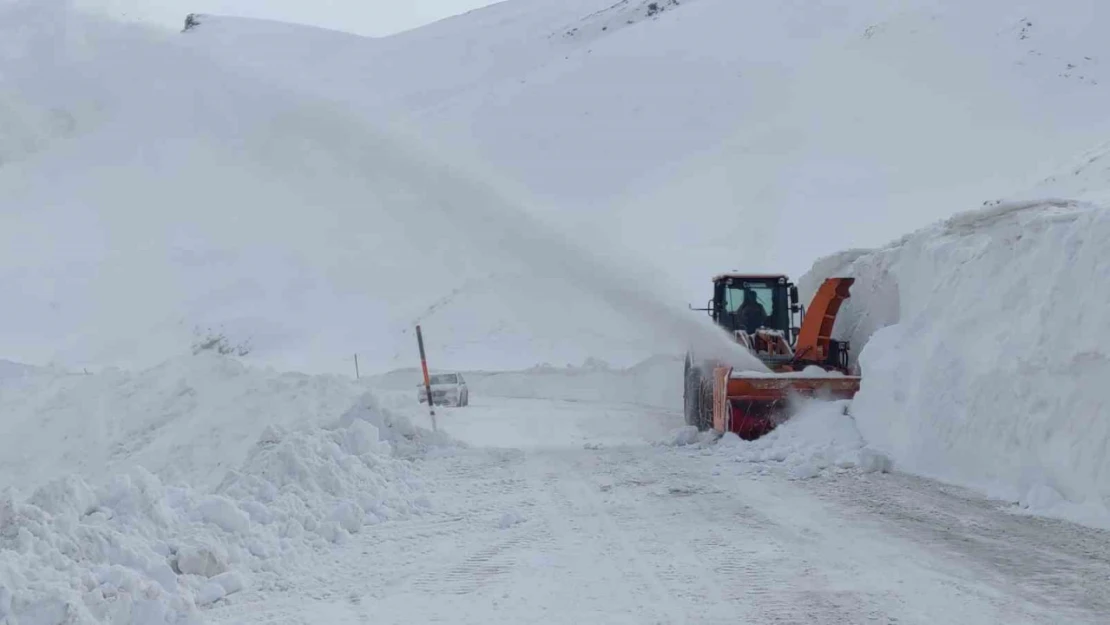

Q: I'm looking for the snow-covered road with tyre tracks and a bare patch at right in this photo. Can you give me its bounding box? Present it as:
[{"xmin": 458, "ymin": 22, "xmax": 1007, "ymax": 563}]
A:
[{"xmin": 208, "ymin": 400, "xmax": 1110, "ymax": 624}]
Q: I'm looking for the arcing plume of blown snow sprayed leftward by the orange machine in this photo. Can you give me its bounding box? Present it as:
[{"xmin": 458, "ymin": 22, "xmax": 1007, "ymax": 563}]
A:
[{"xmin": 244, "ymin": 102, "xmax": 766, "ymax": 371}]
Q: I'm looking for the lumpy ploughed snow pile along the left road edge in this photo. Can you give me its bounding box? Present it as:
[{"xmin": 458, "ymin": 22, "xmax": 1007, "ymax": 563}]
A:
[{"xmin": 0, "ymin": 390, "xmax": 439, "ymax": 625}]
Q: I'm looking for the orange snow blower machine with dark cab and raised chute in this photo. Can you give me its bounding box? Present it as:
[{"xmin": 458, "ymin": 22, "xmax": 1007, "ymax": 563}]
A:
[{"xmin": 684, "ymin": 273, "xmax": 860, "ymax": 441}]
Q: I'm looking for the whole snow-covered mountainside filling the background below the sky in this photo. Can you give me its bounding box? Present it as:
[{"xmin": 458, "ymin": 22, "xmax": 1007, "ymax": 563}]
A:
[{"xmin": 0, "ymin": 0, "xmax": 1110, "ymax": 371}]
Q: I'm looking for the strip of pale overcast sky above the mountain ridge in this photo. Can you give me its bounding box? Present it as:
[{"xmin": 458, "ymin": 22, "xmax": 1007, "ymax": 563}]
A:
[{"xmin": 75, "ymin": 0, "xmax": 508, "ymax": 37}]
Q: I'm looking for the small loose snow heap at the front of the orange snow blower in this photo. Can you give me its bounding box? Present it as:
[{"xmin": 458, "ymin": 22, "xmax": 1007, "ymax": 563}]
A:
[{"xmin": 718, "ymin": 401, "xmax": 891, "ymax": 480}]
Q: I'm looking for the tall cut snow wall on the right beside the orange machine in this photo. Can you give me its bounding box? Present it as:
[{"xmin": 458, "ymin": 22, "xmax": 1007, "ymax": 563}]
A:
[{"xmin": 799, "ymin": 201, "xmax": 1110, "ymax": 525}]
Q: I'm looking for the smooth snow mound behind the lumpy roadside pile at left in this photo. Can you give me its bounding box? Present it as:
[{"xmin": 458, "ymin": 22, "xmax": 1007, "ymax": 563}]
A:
[{"xmin": 0, "ymin": 353, "xmax": 366, "ymax": 495}]
